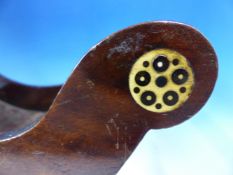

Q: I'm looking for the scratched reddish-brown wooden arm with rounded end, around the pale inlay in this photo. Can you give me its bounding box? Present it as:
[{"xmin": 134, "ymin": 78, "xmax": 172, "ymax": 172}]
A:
[{"xmin": 0, "ymin": 22, "xmax": 217, "ymax": 175}]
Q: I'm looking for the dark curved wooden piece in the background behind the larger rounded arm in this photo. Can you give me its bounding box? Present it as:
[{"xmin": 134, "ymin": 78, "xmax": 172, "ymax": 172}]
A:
[{"xmin": 0, "ymin": 75, "xmax": 61, "ymax": 111}]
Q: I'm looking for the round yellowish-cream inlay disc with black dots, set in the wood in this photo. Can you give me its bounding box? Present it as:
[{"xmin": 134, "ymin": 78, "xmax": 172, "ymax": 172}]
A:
[{"xmin": 129, "ymin": 49, "xmax": 195, "ymax": 113}]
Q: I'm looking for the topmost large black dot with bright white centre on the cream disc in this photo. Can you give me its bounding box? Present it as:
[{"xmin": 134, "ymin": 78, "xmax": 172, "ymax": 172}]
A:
[{"xmin": 153, "ymin": 55, "xmax": 169, "ymax": 72}]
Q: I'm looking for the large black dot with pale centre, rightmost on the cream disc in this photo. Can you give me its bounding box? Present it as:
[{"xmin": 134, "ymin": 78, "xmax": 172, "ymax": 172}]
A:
[{"xmin": 172, "ymin": 69, "xmax": 189, "ymax": 85}]
